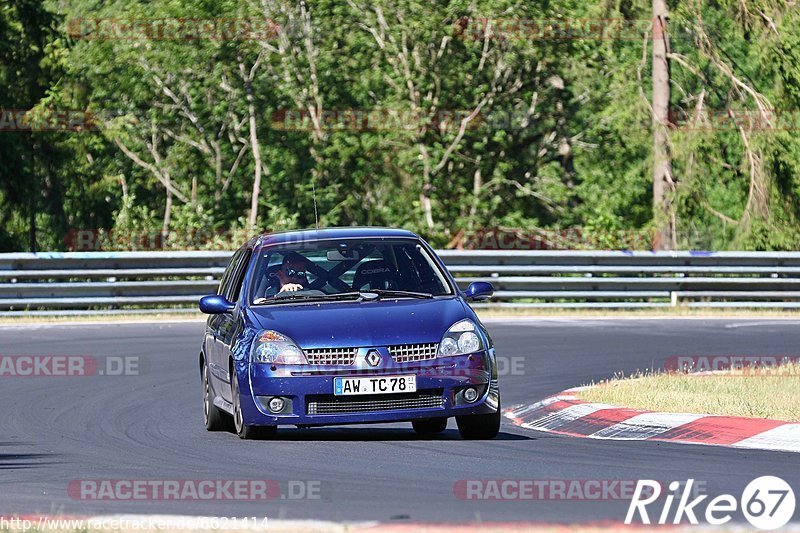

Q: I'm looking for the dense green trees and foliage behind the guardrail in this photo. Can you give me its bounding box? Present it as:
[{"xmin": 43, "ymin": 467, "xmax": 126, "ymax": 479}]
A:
[{"xmin": 0, "ymin": 0, "xmax": 800, "ymax": 250}]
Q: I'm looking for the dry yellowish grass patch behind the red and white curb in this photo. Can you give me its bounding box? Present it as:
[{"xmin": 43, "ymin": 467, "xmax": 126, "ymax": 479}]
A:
[{"xmin": 578, "ymin": 363, "xmax": 800, "ymax": 422}]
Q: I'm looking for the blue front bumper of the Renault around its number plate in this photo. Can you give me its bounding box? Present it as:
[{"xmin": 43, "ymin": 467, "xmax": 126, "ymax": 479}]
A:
[{"xmin": 237, "ymin": 350, "xmax": 499, "ymax": 426}]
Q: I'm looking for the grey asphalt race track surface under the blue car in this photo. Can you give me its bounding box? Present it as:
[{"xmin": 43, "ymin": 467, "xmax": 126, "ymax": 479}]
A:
[{"xmin": 0, "ymin": 318, "xmax": 800, "ymax": 523}]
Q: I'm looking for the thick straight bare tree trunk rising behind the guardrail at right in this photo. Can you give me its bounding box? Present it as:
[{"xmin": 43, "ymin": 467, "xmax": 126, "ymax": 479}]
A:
[{"xmin": 653, "ymin": 0, "xmax": 677, "ymax": 250}]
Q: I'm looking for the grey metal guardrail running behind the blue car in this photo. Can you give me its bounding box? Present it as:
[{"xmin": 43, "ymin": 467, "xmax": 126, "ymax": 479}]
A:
[{"xmin": 0, "ymin": 250, "xmax": 800, "ymax": 315}]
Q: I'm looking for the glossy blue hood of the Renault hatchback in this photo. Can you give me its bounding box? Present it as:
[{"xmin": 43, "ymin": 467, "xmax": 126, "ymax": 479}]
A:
[{"xmin": 250, "ymin": 298, "xmax": 469, "ymax": 349}]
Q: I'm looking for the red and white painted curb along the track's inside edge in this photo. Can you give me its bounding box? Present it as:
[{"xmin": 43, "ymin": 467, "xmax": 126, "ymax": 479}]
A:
[{"xmin": 505, "ymin": 387, "xmax": 800, "ymax": 452}]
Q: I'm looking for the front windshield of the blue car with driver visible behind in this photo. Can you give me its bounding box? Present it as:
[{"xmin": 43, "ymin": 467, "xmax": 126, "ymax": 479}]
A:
[{"xmin": 250, "ymin": 239, "xmax": 453, "ymax": 305}]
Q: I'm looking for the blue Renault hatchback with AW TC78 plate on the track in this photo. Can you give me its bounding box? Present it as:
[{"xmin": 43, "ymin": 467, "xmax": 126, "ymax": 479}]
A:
[{"xmin": 200, "ymin": 228, "xmax": 501, "ymax": 439}]
